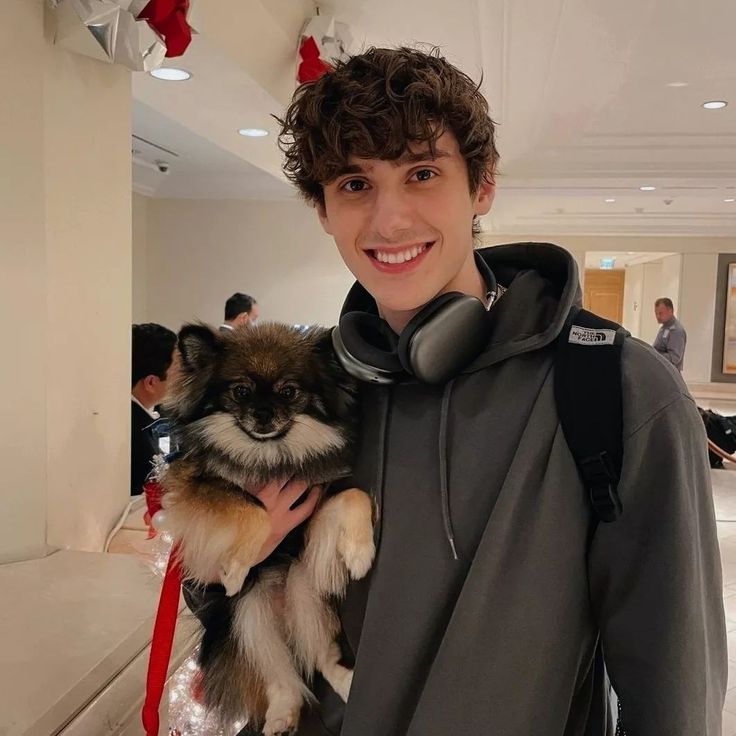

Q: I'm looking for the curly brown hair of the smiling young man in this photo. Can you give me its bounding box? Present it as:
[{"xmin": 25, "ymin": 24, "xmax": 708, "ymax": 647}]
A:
[{"xmin": 277, "ymin": 48, "xmax": 499, "ymax": 204}]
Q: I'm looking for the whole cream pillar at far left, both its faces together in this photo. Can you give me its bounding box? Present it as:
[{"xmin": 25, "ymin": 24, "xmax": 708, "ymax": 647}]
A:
[{"xmin": 0, "ymin": 0, "xmax": 131, "ymax": 562}]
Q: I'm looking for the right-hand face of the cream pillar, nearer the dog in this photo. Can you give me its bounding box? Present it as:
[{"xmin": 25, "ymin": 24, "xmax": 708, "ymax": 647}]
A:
[{"xmin": 39, "ymin": 31, "xmax": 132, "ymax": 550}]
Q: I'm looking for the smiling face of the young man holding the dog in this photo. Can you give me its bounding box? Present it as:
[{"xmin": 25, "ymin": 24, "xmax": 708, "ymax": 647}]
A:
[{"xmin": 318, "ymin": 133, "xmax": 494, "ymax": 322}]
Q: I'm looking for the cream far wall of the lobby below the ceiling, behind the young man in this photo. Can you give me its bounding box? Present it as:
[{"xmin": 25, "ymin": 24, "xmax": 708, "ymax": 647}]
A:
[{"xmin": 133, "ymin": 197, "xmax": 724, "ymax": 380}]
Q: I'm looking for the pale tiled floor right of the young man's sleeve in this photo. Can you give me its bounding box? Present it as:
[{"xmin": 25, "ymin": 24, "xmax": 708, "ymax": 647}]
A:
[{"xmin": 711, "ymin": 465, "xmax": 736, "ymax": 736}]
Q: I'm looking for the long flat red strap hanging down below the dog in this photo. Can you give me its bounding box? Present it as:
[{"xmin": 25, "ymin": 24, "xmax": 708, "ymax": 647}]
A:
[{"xmin": 141, "ymin": 545, "xmax": 182, "ymax": 736}]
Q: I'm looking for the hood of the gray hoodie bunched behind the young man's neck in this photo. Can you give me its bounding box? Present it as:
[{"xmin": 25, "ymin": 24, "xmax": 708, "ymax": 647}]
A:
[{"xmin": 341, "ymin": 243, "xmax": 581, "ymax": 373}]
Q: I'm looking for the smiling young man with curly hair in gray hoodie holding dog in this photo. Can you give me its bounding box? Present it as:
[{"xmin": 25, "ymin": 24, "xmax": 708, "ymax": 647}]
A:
[{"xmin": 194, "ymin": 49, "xmax": 726, "ymax": 736}]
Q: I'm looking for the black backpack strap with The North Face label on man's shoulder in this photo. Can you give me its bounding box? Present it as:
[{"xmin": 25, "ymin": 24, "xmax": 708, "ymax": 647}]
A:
[{"xmin": 555, "ymin": 307, "xmax": 629, "ymax": 522}]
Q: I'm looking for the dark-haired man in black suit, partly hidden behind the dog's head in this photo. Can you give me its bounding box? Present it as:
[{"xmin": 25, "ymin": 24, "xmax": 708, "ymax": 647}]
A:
[{"xmin": 130, "ymin": 323, "xmax": 176, "ymax": 495}]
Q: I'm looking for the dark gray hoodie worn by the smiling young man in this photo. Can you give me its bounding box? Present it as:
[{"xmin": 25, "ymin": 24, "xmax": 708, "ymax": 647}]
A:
[{"xmin": 299, "ymin": 243, "xmax": 727, "ymax": 736}]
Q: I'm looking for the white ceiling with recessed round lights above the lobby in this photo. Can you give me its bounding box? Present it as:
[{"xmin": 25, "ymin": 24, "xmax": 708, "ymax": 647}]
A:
[{"xmin": 133, "ymin": 0, "xmax": 736, "ymax": 236}]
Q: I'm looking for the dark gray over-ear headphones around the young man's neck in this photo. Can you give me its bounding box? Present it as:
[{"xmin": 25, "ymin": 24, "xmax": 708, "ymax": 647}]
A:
[{"xmin": 332, "ymin": 253, "xmax": 498, "ymax": 385}]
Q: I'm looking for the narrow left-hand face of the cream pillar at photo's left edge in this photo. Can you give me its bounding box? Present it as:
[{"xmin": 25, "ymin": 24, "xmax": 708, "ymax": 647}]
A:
[{"xmin": 0, "ymin": 0, "xmax": 46, "ymax": 562}]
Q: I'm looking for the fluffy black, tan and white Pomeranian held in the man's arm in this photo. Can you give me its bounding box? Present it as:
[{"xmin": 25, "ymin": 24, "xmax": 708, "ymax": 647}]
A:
[{"xmin": 161, "ymin": 324, "xmax": 375, "ymax": 736}]
